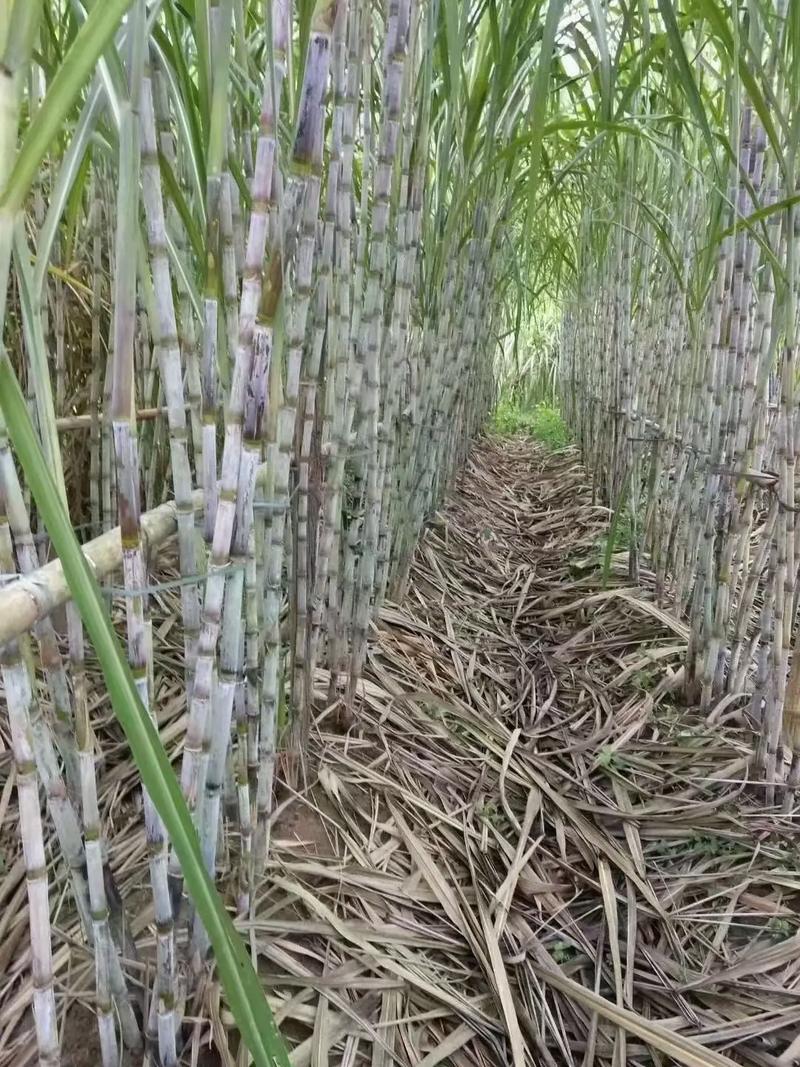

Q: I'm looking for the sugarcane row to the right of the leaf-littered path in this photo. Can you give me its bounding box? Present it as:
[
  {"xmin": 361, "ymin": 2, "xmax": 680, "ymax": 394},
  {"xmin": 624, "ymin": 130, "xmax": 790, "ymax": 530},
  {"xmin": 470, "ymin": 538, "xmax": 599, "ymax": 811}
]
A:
[{"xmin": 560, "ymin": 2, "xmax": 800, "ymax": 803}]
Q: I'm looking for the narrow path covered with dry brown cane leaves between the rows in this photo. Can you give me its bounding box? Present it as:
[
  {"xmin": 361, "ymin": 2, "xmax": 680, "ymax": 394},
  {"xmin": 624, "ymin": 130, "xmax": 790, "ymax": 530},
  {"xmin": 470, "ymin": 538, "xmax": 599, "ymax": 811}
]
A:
[{"xmin": 252, "ymin": 441, "xmax": 800, "ymax": 1067}]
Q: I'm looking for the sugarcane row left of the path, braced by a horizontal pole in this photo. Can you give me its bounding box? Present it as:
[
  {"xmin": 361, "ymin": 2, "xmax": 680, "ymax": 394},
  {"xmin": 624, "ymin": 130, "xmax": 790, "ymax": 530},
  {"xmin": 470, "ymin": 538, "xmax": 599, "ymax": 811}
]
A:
[{"xmin": 0, "ymin": 0, "xmax": 561, "ymax": 1067}]
